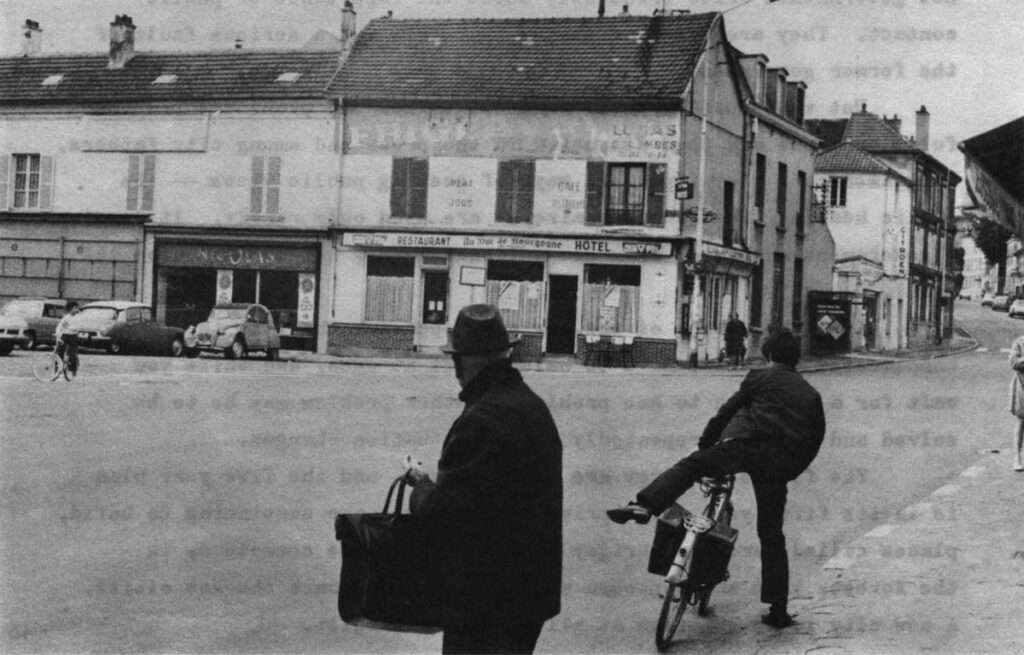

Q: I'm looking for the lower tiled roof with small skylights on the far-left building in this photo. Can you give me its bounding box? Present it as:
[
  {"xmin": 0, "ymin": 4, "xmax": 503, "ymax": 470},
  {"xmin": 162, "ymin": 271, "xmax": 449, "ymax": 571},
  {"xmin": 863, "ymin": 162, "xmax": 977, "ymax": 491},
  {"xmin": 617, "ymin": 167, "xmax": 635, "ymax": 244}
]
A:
[{"xmin": 0, "ymin": 50, "xmax": 339, "ymax": 105}]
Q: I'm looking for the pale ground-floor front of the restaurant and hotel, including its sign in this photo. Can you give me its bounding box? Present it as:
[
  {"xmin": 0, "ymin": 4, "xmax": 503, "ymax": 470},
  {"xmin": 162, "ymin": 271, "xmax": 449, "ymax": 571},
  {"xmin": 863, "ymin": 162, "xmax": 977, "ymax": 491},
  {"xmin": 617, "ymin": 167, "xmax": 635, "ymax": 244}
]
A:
[{"xmin": 329, "ymin": 231, "xmax": 677, "ymax": 365}]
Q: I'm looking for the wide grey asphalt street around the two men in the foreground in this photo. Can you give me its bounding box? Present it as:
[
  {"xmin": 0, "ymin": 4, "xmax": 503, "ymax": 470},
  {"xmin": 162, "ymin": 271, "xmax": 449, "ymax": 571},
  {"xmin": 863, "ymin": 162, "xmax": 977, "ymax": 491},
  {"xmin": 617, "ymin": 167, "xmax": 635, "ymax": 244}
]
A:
[{"xmin": 0, "ymin": 302, "xmax": 1024, "ymax": 653}]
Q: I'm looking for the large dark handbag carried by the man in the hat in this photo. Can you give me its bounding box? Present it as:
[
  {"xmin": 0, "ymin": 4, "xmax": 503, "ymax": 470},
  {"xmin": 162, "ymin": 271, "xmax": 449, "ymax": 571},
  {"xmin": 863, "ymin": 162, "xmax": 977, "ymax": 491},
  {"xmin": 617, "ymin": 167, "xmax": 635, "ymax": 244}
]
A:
[{"xmin": 335, "ymin": 477, "xmax": 442, "ymax": 632}]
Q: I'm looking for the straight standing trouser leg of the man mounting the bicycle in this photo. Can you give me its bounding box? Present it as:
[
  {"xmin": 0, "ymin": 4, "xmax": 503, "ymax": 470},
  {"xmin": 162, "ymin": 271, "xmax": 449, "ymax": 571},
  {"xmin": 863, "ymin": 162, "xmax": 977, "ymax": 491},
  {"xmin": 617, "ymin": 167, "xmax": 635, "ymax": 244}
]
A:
[{"xmin": 752, "ymin": 478, "xmax": 790, "ymax": 603}]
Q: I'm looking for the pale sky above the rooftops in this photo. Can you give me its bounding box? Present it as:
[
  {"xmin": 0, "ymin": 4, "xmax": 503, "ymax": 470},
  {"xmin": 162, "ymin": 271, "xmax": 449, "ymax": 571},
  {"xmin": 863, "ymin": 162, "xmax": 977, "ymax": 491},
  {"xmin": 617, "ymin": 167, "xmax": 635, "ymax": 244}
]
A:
[{"xmin": 0, "ymin": 0, "xmax": 1024, "ymax": 184}]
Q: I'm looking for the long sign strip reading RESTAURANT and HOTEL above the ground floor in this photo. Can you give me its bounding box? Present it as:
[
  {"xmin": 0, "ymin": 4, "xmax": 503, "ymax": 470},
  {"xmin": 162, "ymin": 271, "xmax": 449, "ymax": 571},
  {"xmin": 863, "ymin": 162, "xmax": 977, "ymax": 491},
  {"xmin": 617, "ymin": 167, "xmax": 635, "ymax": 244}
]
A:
[{"xmin": 341, "ymin": 232, "xmax": 671, "ymax": 257}]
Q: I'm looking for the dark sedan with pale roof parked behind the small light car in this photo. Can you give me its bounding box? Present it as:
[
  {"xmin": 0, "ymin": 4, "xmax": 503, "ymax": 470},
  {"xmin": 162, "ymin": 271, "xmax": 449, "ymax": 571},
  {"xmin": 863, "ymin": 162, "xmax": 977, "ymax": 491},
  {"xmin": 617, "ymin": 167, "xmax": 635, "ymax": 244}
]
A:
[{"xmin": 71, "ymin": 300, "xmax": 185, "ymax": 357}]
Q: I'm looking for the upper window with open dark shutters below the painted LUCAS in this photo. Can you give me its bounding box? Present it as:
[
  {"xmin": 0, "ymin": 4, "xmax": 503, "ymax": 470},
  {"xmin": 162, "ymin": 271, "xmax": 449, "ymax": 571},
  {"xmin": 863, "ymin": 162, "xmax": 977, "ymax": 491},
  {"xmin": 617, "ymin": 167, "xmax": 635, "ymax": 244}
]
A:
[{"xmin": 587, "ymin": 162, "xmax": 666, "ymax": 227}]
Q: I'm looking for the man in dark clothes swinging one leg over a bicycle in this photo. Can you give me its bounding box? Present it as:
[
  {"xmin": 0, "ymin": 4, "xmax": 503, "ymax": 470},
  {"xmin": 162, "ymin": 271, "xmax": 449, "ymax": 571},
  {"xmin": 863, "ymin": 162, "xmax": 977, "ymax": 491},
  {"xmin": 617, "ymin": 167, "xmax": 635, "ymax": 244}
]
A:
[{"xmin": 608, "ymin": 329, "xmax": 825, "ymax": 627}]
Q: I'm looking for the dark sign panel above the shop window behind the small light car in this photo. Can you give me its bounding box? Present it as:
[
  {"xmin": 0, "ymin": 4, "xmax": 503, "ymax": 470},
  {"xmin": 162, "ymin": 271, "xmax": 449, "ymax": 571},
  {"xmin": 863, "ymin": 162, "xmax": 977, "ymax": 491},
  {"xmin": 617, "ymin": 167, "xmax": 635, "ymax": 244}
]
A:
[{"xmin": 157, "ymin": 244, "xmax": 316, "ymax": 272}]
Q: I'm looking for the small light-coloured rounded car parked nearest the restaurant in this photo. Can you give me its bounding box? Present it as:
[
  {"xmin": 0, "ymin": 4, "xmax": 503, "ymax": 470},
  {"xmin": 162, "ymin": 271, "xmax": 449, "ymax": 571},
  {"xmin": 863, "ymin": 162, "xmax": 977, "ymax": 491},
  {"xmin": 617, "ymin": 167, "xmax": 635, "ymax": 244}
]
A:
[{"xmin": 185, "ymin": 303, "xmax": 281, "ymax": 359}]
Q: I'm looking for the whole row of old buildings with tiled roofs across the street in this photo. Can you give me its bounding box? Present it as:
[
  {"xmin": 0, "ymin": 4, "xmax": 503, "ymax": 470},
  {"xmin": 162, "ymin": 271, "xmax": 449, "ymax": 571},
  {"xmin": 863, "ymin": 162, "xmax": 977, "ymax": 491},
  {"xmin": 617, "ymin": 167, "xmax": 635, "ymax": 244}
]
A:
[{"xmin": 0, "ymin": 3, "xmax": 959, "ymax": 364}]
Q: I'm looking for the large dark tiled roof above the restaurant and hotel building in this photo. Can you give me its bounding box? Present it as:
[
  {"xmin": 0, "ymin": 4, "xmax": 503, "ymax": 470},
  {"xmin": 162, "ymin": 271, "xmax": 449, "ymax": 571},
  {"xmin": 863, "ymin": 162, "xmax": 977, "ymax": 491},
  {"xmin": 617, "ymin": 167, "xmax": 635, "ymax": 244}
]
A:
[{"xmin": 331, "ymin": 13, "xmax": 717, "ymax": 106}]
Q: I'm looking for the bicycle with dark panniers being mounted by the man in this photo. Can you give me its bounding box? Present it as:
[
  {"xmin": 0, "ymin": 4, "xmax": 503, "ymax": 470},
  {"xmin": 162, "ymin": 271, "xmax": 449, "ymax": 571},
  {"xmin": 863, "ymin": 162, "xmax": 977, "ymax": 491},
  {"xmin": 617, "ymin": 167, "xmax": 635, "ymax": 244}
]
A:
[{"xmin": 647, "ymin": 475, "xmax": 738, "ymax": 651}]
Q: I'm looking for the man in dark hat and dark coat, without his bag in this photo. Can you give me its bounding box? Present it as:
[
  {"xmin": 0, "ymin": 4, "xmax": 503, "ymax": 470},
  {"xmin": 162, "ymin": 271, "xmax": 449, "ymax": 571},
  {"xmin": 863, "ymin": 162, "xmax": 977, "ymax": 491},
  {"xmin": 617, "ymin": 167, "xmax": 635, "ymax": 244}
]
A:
[{"xmin": 409, "ymin": 305, "xmax": 562, "ymax": 653}]
